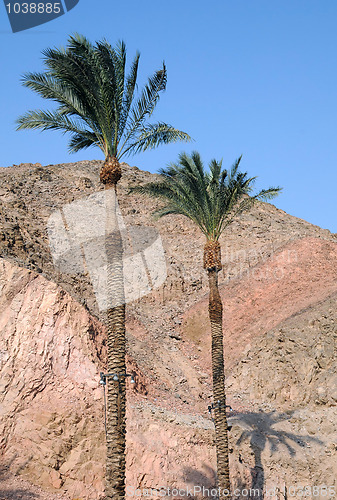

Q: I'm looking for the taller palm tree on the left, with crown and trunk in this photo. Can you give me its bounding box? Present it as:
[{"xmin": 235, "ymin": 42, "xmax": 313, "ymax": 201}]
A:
[{"xmin": 17, "ymin": 34, "xmax": 190, "ymax": 500}]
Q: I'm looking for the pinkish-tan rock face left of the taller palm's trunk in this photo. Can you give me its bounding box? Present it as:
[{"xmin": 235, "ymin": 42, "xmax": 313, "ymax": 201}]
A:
[{"xmin": 0, "ymin": 260, "xmax": 104, "ymax": 496}]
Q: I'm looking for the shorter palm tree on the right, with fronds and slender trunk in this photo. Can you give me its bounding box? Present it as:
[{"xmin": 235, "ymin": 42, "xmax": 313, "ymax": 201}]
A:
[{"xmin": 132, "ymin": 152, "xmax": 280, "ymax": 492}]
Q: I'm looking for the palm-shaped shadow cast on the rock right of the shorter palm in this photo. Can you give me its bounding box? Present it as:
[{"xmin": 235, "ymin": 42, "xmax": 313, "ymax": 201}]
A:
[{"xmin": 230, "ymin": 410, "xmax": 323, "ymax": 498}]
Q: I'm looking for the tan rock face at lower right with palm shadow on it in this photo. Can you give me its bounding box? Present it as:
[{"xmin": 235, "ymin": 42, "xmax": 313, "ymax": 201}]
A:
[{"xmin": 228, "ymin": 293, "xmax": 337, "ymax": 497}]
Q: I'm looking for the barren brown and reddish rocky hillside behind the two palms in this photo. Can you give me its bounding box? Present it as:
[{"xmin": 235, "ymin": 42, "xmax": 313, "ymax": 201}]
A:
[{"xmin": 0, "ymin": 161, "xmax": 337, "ymax": 499}]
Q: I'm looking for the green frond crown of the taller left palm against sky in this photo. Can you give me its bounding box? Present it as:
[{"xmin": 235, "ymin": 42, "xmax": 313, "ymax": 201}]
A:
[{"xmin": 17, "ymin": 34, "xmax": 190, "ymax": 160}]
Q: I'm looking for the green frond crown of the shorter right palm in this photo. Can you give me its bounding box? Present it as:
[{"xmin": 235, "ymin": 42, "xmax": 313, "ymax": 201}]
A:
[{"xmin": 134, "ymin": 152, "xmax": 280, "ymax": 241}]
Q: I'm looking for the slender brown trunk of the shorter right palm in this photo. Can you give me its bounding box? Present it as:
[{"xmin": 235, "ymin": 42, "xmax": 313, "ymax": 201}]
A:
[{"xmin": 208, "ymin": 269, "xmax": 230, "ymax": 498}]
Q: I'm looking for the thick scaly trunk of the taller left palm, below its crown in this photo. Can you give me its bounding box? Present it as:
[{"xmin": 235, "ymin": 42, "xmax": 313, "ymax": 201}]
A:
[{"xmin": 105, "ymin": 189, "xmax": 126, "ymax": 500}]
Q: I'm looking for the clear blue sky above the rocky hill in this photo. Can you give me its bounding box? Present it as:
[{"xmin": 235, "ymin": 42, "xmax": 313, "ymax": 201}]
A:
[{"xmin": 0, "ymin": 0, "xmax": 337, "ymax": 232}]
